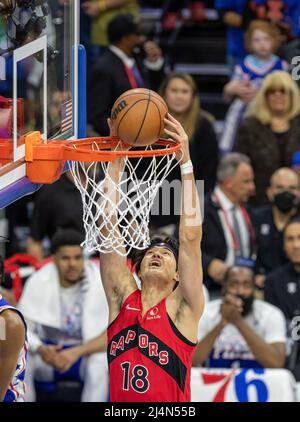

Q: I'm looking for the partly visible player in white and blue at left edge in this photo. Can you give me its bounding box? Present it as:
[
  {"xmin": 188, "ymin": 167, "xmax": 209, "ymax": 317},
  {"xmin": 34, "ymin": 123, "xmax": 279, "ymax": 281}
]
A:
[{"xmin": 0, "ymin": 254, "xmax": 27, "ymax": 402}]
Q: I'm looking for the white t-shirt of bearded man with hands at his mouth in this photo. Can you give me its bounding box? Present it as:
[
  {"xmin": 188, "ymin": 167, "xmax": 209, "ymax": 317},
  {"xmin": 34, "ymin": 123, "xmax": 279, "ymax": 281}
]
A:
[{"xmin": 198, "ymin": 299, "xmax": 286, "ymax": 368}]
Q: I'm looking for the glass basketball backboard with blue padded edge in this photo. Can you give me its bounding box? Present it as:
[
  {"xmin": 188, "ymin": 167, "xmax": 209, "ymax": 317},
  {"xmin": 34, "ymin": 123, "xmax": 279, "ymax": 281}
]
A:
[{"xmin": 0, "ymin": 0, "xmax": 85, "ymax": 208}]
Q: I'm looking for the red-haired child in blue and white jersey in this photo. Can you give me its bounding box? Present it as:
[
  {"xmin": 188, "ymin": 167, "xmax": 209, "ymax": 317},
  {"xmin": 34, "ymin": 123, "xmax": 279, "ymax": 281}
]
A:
[{"xmin": 220, "ymin": 20, "xmax": 288, "ymax": 152}]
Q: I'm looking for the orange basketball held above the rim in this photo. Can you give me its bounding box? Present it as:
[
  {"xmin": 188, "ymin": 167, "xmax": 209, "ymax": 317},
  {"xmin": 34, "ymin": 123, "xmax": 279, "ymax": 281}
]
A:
[{"xmin": 111, "ymin": 88, "xmax": 168, "ymax": 146}]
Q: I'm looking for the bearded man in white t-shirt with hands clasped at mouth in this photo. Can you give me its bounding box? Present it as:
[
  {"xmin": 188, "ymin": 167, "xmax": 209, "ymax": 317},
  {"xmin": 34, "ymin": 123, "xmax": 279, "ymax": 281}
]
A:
[{"xmin": 193, "ymin": 266, "xmax": 286, "ymax": 368}]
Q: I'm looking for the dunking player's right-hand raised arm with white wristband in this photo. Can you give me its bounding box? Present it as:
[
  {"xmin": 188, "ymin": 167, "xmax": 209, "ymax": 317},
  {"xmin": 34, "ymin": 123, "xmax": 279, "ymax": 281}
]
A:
[{"xmin": 165, "ymin": 114, "xmax": 204, "ymax": 320}]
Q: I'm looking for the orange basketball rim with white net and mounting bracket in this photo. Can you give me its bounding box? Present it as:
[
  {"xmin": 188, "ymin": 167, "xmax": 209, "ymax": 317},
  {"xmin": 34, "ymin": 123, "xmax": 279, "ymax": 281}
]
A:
[{"xmin": 25, "ymin": 132, "xmax": 181, "ymax": 255}]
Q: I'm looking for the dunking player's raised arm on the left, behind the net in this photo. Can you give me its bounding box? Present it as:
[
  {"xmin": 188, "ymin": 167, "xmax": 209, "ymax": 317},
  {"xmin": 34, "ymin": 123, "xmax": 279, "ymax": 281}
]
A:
[{"xmin": 100, "ymin": 121, "xmax": 137, "ymax": 321}]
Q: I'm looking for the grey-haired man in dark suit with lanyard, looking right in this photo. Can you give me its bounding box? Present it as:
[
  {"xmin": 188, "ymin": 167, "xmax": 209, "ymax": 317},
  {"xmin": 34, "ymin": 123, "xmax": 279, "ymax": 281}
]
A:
[{"xmin": 202, "ymin": 153, "xmax": 256, "ymax": 292}]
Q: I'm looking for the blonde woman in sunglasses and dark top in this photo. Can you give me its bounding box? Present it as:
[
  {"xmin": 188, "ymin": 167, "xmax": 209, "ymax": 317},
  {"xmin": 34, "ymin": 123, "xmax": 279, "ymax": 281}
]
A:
[{"xmin": 235, "ymin": 71, "xmax": 300, "ymax": 206}]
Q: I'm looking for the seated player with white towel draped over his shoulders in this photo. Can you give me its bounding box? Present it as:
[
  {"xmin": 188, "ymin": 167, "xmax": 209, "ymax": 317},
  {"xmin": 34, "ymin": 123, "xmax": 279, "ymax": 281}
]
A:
[{"xmin": 19, "ymin": 229, "xmax": 108, "ymax": 401}]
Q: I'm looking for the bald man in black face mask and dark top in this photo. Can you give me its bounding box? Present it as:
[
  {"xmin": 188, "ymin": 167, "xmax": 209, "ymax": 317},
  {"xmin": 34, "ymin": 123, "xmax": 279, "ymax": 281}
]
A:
[{"xmin": 254, "ymin": 167, "xmax": 300, "ymax": 287}]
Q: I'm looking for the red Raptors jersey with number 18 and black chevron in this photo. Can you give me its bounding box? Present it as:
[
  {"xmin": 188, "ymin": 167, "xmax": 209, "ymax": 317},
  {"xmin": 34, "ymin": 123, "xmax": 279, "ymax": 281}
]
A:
[{"xmin": 107, "ymin": 290, "xmax": 195, "ymax": 402}]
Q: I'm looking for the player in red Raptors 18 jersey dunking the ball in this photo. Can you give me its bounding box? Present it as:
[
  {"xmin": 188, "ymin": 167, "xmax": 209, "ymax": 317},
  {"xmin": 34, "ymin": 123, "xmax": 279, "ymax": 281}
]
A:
[{"xmin": 100, "ymin": 115, "xmax": 204, "ymax": 402}]
